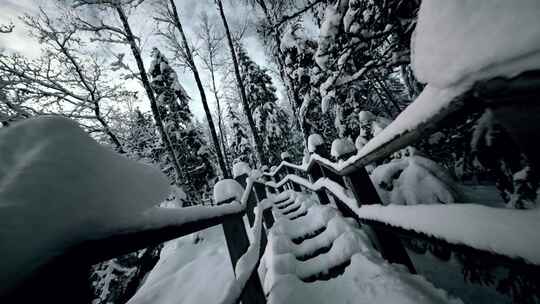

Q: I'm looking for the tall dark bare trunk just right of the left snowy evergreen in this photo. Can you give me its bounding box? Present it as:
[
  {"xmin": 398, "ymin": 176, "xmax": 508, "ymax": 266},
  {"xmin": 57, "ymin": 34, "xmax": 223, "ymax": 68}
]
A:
[{"xmin": 169, "ymin": 0, "xmax": 231, "ymax": 178}]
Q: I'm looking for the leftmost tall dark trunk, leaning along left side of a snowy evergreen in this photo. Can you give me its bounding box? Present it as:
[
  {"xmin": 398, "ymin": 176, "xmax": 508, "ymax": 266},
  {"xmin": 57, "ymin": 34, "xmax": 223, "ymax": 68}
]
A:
[{"xmin": 115, "ymin": 5, "xmax": 185, "ymax": 183}]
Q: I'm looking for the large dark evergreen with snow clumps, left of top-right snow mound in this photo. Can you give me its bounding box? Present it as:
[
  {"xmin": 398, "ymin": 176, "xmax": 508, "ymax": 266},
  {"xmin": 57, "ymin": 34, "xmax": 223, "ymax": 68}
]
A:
[{"xmin": 315, "ymin": 0, "xmax": 418, "ymax": 138}]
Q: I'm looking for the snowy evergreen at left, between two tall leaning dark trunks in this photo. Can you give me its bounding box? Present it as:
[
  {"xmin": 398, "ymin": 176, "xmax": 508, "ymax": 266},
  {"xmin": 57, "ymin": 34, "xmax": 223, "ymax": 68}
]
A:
[{"xmin": 148, "ymin": 49, "xmax": 215, "ymax": 201}]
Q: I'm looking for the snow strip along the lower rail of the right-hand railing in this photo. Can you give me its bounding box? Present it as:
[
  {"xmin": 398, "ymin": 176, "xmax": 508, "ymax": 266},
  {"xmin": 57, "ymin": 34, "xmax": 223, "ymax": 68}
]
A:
[{"xmin": 265, "ymin": 174, "xmax": 540, "ymax": 265}]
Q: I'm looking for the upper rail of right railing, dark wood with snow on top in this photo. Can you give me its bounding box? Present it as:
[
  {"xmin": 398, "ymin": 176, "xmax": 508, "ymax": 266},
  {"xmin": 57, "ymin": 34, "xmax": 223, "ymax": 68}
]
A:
[{"xmin": 263, "ymin": 71, "xmax": 540, "ymax": 177}]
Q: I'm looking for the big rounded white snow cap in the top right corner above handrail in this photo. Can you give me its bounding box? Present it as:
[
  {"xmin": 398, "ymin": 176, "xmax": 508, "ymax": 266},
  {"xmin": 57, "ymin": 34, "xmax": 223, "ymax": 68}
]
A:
[{"xmin": 411, "ymin": 0, "xmax": 540, "ymax": 88}]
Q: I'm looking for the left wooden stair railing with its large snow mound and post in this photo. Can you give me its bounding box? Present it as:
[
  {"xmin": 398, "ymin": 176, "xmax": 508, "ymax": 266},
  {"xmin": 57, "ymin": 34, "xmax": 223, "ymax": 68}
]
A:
[{"xmin": 0, "ymin": 117, "xmax": 265, "ymax": 303}]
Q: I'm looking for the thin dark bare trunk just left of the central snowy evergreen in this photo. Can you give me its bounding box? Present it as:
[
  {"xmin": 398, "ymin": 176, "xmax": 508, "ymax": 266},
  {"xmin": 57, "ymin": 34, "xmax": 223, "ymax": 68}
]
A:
[{"xmin": 215, "ymin": 0, "xmax": 267, "ymax": 166}]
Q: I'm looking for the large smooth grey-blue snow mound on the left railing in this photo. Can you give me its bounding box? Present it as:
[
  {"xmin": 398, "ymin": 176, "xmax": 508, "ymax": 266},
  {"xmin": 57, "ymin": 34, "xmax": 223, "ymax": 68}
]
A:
[{"xmin": 0, "ymin": 117, "xmax": 169, "ymax": 291}]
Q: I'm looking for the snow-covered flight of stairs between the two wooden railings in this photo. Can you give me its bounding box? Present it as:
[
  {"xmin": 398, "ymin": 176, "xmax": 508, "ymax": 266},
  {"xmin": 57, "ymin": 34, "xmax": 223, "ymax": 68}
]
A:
[{"xmin": 260, "ymin": 191, "xmax": 462, "ymax": 303}]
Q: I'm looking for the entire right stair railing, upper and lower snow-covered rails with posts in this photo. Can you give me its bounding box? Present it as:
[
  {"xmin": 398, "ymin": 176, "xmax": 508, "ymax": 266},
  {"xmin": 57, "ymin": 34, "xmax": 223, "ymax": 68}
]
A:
[{"xmin": 264, "ymin": 71, "xmax": 540, "ymax": 302}]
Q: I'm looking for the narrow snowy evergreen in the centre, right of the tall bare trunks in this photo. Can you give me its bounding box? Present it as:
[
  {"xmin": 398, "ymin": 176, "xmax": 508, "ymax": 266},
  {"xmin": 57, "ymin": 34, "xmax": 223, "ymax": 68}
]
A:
[{"xmin": 237, "ymin": 46, "xmax": 291, "ymax": 164}]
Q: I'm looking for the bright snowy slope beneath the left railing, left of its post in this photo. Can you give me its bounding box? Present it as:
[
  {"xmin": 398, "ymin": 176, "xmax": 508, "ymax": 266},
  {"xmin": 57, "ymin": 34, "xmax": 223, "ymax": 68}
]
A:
[{"xmin": 128, "ymin": 226, "xmax": 234, "ymax": 304}]
